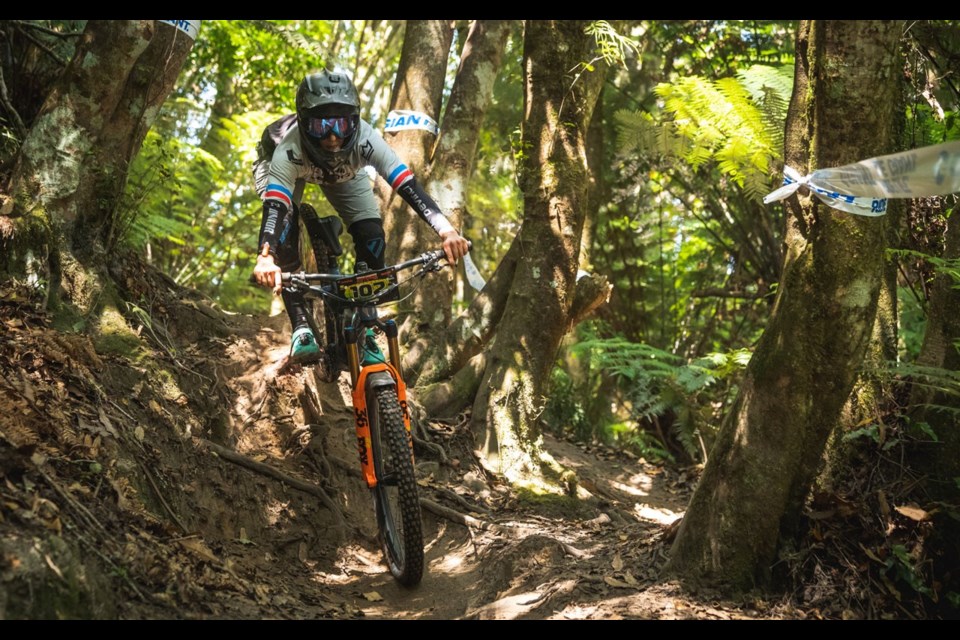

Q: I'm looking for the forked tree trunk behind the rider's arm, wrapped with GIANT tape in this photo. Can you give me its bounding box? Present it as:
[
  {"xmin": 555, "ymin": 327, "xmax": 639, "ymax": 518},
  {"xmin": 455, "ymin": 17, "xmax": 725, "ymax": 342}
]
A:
[{"xmin": 378, "ymin": 20, "xmax": 510, "ymax": 338}]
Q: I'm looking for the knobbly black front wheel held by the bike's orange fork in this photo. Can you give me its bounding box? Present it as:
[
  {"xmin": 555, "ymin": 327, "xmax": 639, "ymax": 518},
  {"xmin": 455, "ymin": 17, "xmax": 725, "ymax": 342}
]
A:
[{"xmin": 367, "ymin": 386, "xmax": 423, "ymax": 587}]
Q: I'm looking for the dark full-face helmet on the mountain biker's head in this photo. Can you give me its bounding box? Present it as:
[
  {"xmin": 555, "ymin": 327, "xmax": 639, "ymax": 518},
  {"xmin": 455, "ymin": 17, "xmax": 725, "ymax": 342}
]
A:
[{"xmin": 297, "ymin": 70, "xmax": 360, "ymax": 162}]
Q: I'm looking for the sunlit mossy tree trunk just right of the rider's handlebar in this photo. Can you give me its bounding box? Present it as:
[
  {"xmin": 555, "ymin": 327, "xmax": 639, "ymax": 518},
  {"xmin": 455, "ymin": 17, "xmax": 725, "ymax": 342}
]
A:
[{"xmin": 472, "ymin": 20, "xmax": 606, "ymax": 481}]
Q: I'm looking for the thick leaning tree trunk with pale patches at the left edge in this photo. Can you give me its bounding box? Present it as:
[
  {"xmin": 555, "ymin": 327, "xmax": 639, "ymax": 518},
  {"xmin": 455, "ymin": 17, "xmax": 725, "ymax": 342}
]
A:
[{"xmin": 0, "ymin": 20, "xmax": 193, "ymax": 316}]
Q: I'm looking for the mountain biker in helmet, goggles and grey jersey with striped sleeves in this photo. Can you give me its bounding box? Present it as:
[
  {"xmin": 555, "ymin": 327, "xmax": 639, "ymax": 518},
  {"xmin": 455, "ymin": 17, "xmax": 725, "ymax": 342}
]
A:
[{"xmin": 253, "ymin": 70, "xmax": 468, "ymax": 362}]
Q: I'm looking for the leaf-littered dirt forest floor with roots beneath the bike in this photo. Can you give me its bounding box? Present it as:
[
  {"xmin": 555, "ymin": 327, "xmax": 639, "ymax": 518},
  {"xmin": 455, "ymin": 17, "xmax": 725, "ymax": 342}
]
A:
[{"xmin": 0, "ymin": 258, "xmax": 928, "ymax": 620}]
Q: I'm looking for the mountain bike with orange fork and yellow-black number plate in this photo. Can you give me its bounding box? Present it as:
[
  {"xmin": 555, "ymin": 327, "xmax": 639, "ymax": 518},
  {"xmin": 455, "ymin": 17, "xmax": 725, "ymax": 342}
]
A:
[{"xmin": 282, "ymin": 218, "xmax": 468, "ymax": 586}]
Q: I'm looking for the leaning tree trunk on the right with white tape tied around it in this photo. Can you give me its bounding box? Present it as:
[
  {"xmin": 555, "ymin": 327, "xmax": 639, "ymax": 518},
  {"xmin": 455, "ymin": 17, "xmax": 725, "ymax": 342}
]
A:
[{"xmin": 667, "ymin": 20, "xmax": 902, "ymax": 591}]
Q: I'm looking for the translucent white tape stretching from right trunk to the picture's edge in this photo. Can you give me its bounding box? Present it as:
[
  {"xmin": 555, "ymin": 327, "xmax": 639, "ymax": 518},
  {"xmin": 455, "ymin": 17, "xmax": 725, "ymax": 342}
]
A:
[{"xmin": 763, "ymin": 140, "xmax": 960, "ymax": 216}]
